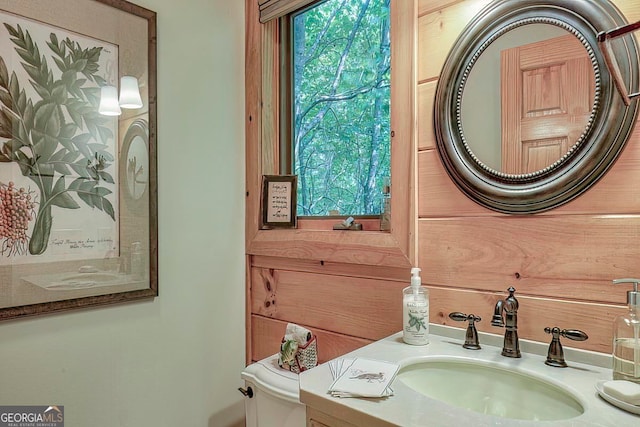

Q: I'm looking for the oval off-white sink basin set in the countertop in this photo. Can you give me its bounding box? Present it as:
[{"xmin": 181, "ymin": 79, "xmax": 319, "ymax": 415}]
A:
[{"xmin": 398, "ymin": 358, "xmax": 584, "ymax": 421}]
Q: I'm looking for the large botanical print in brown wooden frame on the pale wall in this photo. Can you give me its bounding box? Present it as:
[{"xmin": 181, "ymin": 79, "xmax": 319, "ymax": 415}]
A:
[{"xmin": 0, "ymin": 0, "xmax": 158, "ymax": 320}]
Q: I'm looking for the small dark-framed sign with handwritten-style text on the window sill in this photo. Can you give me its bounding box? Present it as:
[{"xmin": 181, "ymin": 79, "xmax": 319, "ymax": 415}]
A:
[{"xmin": 261, "ymin": 175, "xmax": 298, "ymax": 229}]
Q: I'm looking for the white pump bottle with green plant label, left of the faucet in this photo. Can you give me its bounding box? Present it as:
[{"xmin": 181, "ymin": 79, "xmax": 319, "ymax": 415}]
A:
[{"xmin": 402, "ymin": 267, "xmax": 429, "ymax": 345}]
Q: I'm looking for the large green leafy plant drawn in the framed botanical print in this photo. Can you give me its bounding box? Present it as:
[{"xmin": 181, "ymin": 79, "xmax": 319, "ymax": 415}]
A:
[{"xmin": 0, "ymin": 23, "xmax": 115, "ymax": 255}]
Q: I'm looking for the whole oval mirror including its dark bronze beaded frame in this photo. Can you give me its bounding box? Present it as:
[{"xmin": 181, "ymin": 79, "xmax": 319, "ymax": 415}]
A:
[{"xmin": 434, "ymin": 0, "xmax": 638, "ymax": 213}]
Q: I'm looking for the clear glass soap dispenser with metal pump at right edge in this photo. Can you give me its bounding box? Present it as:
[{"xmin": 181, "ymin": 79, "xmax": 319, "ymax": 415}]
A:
[{"xmin": 613, "ymin": 279, "xmax": 640, "ymax": 384}]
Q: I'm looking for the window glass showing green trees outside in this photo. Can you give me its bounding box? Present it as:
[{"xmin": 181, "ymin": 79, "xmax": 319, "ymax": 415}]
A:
[{"xmin": 281, "ymin": 0, "xmax": 391, "ymax": 216}]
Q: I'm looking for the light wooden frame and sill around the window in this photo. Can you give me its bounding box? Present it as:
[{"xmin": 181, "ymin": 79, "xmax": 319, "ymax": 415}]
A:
[{"xmin": 245, "ymin": 0, "xmax": 417, "ymax": 268}]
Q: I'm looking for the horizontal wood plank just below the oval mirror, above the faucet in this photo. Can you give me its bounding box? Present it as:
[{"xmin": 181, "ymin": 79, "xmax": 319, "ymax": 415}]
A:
[{"xmin": 418, "ymin": 216, "xmax": 640, "ymax": 304}]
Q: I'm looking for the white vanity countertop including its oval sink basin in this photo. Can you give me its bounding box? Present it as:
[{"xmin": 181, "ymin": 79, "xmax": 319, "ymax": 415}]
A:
[{"xmin": 299, "ymin": 323, "xmax": 640, "ymax": 427}]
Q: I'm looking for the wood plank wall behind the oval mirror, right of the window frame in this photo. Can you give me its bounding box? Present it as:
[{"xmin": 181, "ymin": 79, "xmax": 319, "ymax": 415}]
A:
[{"xmin": 417, "ymin": 0, "xmax": 640, "ymax": 352}]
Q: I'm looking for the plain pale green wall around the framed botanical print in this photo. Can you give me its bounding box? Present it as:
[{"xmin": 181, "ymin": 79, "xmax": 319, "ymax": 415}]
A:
[{"xmin": 0, "ymin": 0, "xmax": 244, "ymax": 427}]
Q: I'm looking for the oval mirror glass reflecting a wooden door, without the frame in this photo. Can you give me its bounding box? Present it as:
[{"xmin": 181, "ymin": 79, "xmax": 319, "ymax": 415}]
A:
[{"xmin": 460, "ymin": 24, "xmax": 596, "ymax": 175}]
